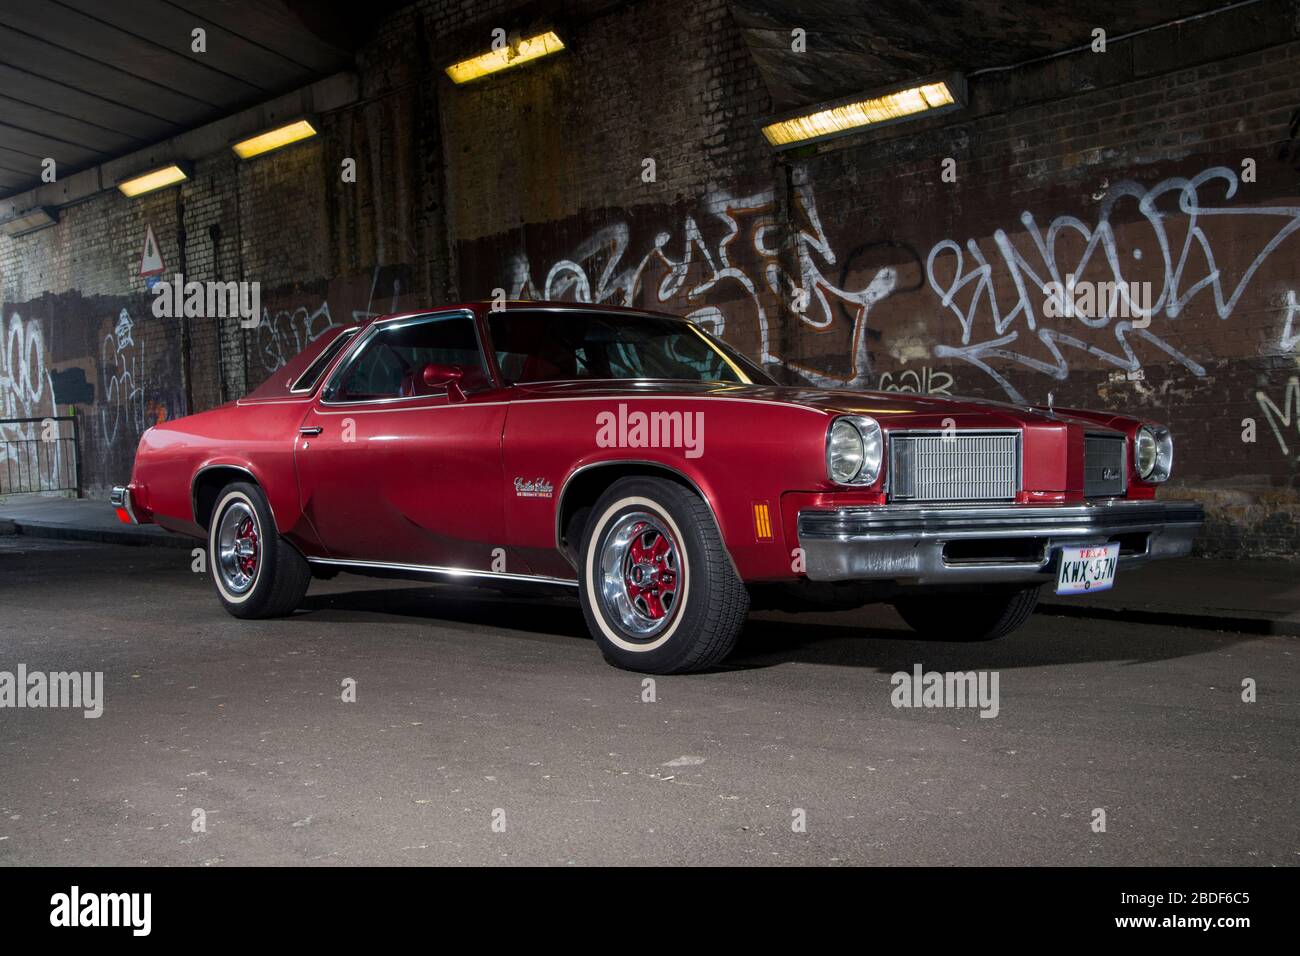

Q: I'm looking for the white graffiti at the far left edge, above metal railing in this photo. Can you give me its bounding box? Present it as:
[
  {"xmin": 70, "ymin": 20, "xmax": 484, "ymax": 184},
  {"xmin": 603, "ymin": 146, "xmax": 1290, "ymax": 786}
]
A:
[{"xmin": 0, "ymin": 312, "xmax": 61, "ymax": 488}]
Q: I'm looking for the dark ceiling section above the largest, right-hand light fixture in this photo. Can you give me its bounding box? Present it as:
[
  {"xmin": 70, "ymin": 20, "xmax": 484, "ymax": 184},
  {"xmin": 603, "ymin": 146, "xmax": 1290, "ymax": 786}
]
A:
[{"xmin": 732, "ymin": 0, "xmax": 1229, "ymax": 111}]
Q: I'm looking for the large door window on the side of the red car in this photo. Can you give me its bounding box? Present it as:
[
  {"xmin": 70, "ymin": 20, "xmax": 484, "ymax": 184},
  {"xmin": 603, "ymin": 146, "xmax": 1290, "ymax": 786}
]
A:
[{"xmin": 324, "ymin": 315, "xmax": 488, "ymax": 402}]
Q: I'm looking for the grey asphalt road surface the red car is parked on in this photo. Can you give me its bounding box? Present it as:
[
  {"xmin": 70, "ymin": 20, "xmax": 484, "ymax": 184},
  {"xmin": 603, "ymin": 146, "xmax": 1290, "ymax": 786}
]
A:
[{"xmin": 0, "ymin": 536, "xmax": 1300, "ymax": 865}]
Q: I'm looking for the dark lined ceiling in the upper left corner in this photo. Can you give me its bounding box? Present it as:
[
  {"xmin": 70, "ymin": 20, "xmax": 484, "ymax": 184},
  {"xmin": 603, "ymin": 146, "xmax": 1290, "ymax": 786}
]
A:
[{"xmin": 0, "ymin": 0, "xmax": 398, "ymax": 198}]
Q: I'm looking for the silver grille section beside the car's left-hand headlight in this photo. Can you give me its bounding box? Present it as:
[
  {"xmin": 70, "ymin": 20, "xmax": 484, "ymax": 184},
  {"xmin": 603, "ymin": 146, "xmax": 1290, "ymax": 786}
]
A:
[{"xmin": 889, "ymin": 432, "xmax": 1021, "ymax": 501}]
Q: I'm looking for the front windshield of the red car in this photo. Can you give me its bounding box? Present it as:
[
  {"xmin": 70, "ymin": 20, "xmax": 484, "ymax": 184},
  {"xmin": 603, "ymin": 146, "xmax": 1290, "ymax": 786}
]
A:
[{"xmin": 488, "ymin": 310, "xmax": 774, "ymax": 385}]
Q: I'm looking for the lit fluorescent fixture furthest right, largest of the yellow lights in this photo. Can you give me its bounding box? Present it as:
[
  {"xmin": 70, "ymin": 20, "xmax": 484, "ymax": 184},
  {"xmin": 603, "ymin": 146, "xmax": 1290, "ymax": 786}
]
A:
[{"xmin": 763, "ymin": 74, "xmax": 966, "ymax": 150}]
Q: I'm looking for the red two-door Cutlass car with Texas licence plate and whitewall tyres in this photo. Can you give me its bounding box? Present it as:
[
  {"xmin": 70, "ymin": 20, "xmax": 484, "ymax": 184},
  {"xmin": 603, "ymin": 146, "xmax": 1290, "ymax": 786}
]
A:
[{"xmin": 113, "ymin": 303, "xmax": 1203, "ymax": 674}]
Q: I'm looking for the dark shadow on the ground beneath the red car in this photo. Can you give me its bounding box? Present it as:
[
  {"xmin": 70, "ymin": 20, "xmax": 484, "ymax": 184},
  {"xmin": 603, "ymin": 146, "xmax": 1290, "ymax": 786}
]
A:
[{"xmin": 294, "ymin": 587, "xmax": 1256, "ymax": 674}]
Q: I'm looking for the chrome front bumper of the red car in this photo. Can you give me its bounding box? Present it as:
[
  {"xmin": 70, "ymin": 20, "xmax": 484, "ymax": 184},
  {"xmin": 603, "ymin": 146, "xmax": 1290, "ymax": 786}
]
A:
[{"xmin": 798, "ymin": 501, "xmax": 1205, "ymax": 584}]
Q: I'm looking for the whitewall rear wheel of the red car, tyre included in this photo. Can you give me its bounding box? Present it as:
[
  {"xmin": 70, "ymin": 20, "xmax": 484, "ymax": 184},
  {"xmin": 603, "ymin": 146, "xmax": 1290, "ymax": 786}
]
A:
[{"xmin": 208, "ymin": 481, "xmax": 312, "ymax": 618}]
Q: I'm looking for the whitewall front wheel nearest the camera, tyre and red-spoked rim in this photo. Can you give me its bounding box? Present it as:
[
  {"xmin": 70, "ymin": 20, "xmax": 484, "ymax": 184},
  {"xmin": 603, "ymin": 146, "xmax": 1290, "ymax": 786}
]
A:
[{"xmin": 579, "ymin": 477, "xmax": 749, "ymax": 674}]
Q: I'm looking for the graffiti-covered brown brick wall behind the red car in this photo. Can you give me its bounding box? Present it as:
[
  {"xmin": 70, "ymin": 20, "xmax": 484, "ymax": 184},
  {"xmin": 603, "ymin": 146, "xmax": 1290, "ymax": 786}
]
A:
[{"xmin": 0, "ymin": 0, "xmax": 1300, "ymax": 555}]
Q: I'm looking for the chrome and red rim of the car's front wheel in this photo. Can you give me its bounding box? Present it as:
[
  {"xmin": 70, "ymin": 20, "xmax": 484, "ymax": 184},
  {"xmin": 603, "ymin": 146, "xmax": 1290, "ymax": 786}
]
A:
[{"xmin": 601, "ymin": 511, "xmax": 686, "ymax": 640}]
